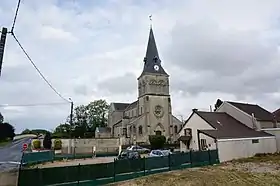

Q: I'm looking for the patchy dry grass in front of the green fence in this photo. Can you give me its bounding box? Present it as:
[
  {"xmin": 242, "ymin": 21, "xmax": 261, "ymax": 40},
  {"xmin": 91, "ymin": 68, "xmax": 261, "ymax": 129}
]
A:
[{"xmin": 111, "ymin": 154, "xmax": 280, "ymax": 186}]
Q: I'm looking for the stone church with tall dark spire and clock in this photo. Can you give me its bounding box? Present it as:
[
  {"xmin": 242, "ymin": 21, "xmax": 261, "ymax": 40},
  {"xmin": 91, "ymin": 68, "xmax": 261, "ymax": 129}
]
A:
[{"xmin": 104, "ymin": 28, "xmax": 182, "ymax": 144}]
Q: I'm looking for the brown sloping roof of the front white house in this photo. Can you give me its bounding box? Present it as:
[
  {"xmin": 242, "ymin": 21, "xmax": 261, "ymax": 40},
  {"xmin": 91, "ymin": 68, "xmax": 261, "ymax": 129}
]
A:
[{"xmin": 195, "ymin": 111, "xmax": 273, "ymax": 139}]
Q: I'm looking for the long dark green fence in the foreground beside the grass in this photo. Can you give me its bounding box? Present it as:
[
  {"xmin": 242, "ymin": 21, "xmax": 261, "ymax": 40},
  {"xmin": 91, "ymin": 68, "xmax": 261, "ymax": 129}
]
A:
[{"xmin": 18, "ymin": 150, "xmax": 219, "ymax": 186}]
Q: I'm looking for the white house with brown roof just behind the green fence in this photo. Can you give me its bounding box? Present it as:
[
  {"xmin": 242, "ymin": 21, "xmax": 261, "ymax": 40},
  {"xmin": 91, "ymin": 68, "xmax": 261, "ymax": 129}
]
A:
[{"xmin": 179, "ymin": 109, "xmax": 277, "ymax": 162}]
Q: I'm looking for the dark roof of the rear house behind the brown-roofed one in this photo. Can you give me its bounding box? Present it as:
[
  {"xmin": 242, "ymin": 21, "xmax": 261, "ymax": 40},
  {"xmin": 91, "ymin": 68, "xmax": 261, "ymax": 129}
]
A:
[{"xmin": 227, "ymin": 101, "xmax": 274, "ymax": 121}]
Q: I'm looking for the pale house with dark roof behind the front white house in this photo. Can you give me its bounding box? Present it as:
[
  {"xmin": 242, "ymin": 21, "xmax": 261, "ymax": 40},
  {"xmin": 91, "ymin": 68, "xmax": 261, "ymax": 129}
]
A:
[{"xmin": 216, "ymin": 101, "xmax": 280, "ymax": 130}]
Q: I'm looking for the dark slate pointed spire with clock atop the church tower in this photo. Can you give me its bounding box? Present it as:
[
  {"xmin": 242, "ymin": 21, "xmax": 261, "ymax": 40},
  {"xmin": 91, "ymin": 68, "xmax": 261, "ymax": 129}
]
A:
[{"xmin": 141, "ymin": 27, "xmax": 168, "ymax": 76}]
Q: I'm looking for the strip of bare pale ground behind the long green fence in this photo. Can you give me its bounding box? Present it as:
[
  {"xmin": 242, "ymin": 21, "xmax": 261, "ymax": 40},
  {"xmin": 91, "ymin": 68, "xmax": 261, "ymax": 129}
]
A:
[{"xmin": 30, "ymin": 157, "xmax": 116, "ymax": 168}]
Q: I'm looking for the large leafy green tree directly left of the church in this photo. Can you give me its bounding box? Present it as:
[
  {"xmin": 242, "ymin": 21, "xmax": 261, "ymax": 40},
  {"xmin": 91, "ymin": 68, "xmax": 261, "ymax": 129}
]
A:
[{"xmin": 68, "ymin": 99, "xmax": 109, "ymax": 137}]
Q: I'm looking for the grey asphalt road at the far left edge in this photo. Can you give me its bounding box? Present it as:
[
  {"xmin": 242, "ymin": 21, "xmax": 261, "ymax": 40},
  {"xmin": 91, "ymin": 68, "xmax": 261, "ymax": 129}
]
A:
[{"xmin": 0, "ymin": 138, "xmax": 30, "ymax": 171}]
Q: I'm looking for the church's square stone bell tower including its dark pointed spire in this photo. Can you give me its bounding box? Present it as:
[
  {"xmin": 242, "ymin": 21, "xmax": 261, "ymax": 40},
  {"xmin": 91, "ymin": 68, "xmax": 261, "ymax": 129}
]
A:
[{"xmin": 137, "ymin": 28, "xmax": 172, "ymax": 139}]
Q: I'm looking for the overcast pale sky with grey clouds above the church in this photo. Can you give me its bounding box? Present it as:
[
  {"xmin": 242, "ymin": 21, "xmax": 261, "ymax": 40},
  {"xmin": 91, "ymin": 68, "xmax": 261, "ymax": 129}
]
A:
[{"xmin": 0, "ymin": 0, "xmax": 280, "ymax": 132}]
